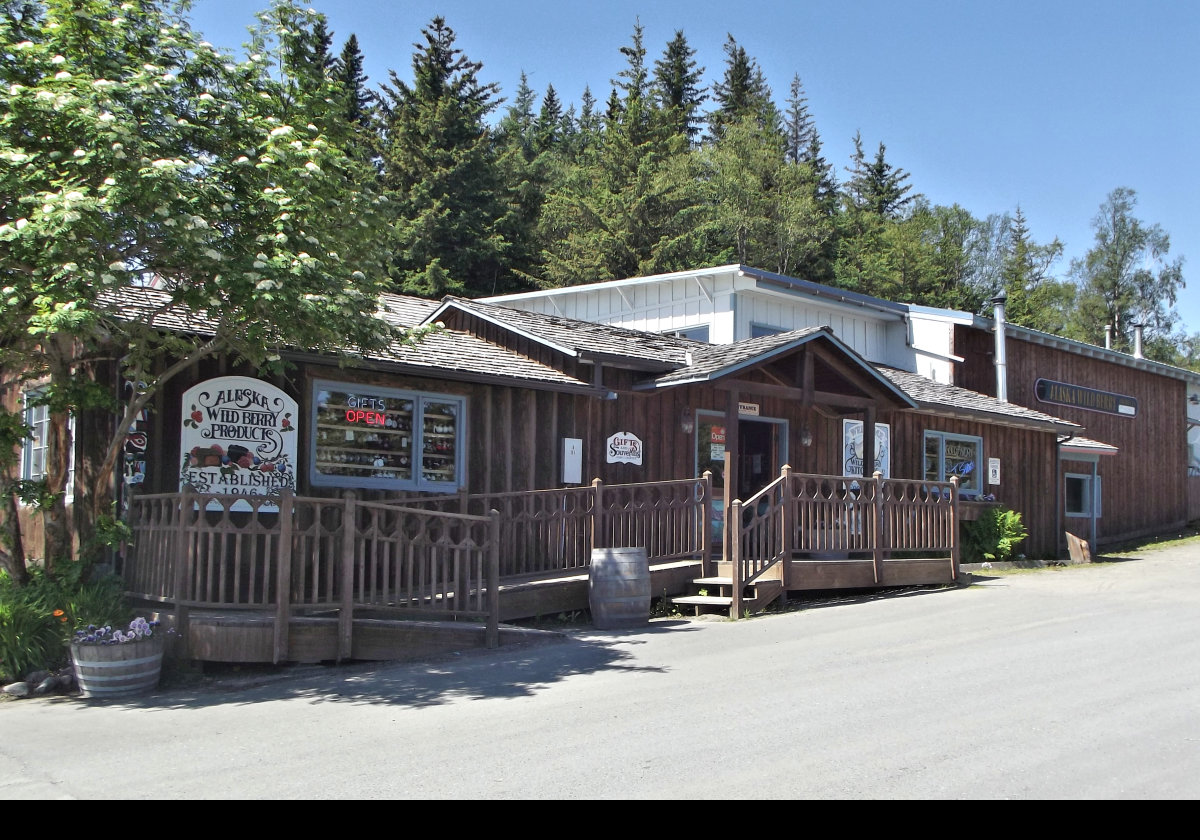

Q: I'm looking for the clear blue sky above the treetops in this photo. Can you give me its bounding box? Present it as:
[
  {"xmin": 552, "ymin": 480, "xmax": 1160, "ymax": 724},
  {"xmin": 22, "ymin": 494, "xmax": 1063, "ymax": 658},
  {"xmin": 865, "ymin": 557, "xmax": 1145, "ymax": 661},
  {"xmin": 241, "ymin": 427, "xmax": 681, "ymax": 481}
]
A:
[{"xmin": 182, "ymin": 0, "xmax": 1200, "ymax": 332}]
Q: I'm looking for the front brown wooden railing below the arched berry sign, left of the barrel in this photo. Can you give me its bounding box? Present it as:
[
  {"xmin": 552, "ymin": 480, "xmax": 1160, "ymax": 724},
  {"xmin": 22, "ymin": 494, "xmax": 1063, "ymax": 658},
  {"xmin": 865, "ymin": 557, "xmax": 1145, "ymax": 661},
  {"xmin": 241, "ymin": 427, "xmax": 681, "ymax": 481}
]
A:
[{"xmin": 129, "ymin": 490, "xmax": 499, "ymax": 661}]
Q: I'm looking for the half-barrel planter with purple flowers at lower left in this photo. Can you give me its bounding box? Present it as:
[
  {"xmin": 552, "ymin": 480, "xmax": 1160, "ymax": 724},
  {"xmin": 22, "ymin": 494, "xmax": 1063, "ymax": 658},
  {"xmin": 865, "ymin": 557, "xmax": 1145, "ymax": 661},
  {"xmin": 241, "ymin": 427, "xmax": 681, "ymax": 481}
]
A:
[{"xmin": 71, "ymin": 617, "xmax": 166, "ymax": 698}]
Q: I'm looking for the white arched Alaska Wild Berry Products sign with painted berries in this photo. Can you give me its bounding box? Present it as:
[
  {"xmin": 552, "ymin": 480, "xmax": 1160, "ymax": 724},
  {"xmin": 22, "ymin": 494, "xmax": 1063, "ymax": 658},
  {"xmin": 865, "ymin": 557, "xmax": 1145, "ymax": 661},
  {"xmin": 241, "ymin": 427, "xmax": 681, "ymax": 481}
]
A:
[{"xmin": 179, "ymin": 377, "xmax": 298, "ymax": 510}]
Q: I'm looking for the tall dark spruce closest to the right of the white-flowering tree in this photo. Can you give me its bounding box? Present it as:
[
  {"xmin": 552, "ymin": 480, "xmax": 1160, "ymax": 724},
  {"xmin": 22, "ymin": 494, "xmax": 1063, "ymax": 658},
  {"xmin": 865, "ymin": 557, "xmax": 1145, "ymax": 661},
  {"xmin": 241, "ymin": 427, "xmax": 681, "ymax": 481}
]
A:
[{"xmin": 382, "ymin": 17, "xmax": 510, "ymax": 296}]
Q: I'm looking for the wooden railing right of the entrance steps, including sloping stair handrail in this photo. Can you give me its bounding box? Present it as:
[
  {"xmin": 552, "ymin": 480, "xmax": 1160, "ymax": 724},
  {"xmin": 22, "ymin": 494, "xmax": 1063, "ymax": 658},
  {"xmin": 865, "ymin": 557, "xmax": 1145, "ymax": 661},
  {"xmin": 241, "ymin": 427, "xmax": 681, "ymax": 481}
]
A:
[{"xmin": 726, "ymin": 467, "xmax": 959, "ymax": 616}]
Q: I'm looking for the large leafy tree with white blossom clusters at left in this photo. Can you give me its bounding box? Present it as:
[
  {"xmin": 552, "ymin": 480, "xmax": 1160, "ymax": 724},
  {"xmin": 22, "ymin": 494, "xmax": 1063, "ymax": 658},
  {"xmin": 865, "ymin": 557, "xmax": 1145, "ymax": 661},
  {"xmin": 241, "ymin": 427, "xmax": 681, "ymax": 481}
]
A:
[{"xmin": 0, "ymin": 0, "xmax": 389, "ymax": 571}]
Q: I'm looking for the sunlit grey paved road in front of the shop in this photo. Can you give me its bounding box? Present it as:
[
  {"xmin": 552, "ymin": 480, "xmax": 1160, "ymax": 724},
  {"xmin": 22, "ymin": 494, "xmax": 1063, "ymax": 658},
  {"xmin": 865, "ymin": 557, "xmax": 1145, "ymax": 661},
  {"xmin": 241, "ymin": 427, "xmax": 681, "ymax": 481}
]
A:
[{"xmin": 0, "ymin": 541, "xmax": 1200, "ymax": 799}]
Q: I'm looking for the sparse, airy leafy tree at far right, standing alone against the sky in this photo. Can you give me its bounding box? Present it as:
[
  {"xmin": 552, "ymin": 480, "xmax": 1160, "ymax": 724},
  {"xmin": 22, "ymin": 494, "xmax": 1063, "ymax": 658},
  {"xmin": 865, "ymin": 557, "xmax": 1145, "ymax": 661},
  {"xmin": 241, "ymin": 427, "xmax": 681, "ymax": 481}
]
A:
[{"xmin": 1068, "ymin": 187, "xmax": 1184, "ymax": 350}]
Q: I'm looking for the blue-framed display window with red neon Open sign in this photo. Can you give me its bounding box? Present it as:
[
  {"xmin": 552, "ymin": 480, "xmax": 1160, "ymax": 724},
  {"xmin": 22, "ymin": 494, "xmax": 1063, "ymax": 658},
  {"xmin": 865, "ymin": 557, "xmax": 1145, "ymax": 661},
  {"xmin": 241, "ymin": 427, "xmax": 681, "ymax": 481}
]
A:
[{"xmin": 310, "ymin": 380, "xmax": 466, "ymax": 492}]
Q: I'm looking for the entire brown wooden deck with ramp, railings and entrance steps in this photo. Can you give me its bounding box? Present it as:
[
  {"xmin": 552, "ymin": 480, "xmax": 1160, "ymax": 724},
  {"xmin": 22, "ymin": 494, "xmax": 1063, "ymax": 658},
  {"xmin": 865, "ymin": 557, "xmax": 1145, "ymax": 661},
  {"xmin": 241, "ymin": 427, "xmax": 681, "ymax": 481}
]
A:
[{"xmin": 122, "ymin": 468, "xmax": 958, "ymax": 662}]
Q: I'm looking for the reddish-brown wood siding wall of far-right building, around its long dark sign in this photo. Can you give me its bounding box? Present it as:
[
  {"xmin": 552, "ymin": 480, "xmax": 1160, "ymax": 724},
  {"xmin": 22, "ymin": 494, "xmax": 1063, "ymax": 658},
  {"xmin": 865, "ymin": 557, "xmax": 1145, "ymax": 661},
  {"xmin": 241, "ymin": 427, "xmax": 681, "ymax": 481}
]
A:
[{"xmin": 955, "ymin": 326, "xmax": 1188, "ymax": 545}]
